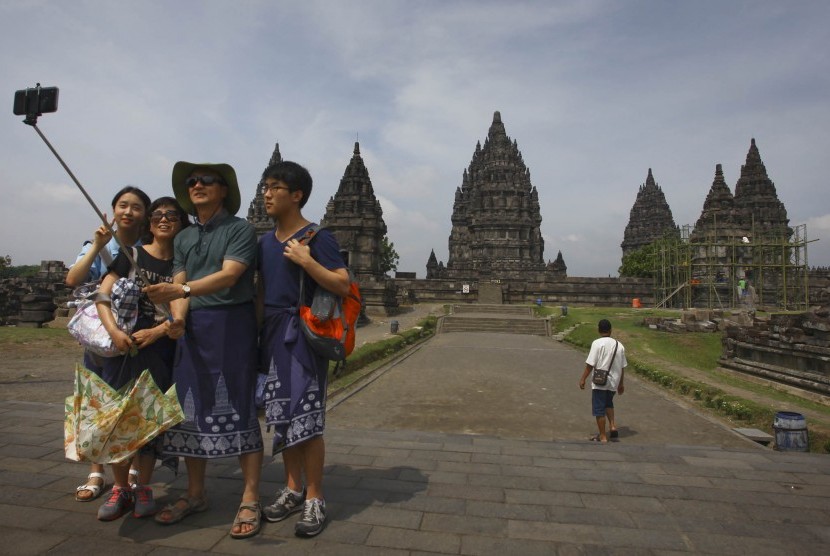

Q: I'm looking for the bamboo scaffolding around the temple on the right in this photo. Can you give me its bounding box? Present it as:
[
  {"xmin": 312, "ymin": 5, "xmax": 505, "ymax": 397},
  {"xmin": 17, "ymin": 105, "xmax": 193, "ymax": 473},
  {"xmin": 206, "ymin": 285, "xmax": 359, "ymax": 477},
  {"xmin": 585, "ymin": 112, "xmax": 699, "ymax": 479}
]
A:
[{"xmin": 652, "ymin": 222, "xmax": 816, "ymax": 311}]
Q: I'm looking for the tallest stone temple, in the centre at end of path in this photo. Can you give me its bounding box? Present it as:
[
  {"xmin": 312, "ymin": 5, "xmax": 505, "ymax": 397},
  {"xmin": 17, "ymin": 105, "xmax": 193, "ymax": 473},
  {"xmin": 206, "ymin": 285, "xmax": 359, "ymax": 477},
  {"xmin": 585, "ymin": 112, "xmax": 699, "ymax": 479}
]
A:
[{"xmin": 442, "ymin": 112, "xmax": 564, "ymax": 279}]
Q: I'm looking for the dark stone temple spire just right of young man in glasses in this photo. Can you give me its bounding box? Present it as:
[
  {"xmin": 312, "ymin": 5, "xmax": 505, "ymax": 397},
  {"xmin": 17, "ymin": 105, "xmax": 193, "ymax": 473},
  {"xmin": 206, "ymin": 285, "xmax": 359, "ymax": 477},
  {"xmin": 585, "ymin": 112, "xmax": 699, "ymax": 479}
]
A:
[{"xmin": 321, "ymin": 142, "xmax": 386, "ymax": 279}]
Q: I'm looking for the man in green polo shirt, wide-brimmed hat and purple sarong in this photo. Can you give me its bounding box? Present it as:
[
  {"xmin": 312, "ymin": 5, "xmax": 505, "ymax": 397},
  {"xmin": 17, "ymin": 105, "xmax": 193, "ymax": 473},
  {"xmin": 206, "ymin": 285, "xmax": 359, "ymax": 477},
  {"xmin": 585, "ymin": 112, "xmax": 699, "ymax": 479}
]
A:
[{"xmin": 146, "ymin": 162, "xmax": 262, "ymax": 538}]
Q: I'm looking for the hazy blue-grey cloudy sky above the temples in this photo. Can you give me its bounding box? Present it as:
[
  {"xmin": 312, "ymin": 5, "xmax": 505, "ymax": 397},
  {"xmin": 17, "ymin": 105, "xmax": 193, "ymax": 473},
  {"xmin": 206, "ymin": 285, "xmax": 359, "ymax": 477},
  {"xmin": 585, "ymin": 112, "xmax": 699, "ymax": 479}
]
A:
[{"xmin": 0, "ymin": 0, "xmax": 830, "ymax": 277}]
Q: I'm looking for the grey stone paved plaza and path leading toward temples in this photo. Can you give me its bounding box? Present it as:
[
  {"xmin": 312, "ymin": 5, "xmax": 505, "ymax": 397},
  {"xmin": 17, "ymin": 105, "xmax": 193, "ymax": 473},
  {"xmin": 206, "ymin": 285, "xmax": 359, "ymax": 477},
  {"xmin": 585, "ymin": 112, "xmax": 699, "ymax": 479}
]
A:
[{"xmin": 0, "ymin": 320, "xmax": 830, "ymax": 555}]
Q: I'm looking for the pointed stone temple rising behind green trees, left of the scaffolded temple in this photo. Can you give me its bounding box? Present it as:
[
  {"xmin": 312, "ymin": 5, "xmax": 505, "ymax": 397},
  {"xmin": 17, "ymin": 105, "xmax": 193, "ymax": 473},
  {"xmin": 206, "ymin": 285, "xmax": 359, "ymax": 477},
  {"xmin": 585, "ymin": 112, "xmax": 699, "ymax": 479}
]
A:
[{"xmin": 621, "ymin": 168, "xmax": 680, "ymax": 256}]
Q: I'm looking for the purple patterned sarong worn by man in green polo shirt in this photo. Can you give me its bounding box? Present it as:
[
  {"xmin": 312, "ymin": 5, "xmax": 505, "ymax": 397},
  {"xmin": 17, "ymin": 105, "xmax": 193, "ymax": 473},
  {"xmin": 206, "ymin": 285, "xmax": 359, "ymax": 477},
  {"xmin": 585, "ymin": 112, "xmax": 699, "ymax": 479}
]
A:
[{"xmin": 164, "ymin": 303, "xmax": 262, "ymax": 459}]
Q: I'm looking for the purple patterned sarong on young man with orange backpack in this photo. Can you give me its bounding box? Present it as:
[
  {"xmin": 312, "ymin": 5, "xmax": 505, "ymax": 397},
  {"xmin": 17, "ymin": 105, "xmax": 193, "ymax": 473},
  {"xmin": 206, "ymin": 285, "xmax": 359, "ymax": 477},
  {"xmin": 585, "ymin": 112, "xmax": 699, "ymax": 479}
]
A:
[{"xmin": 260, "ymin": 307, "xmax": 328, "ymax": 454}]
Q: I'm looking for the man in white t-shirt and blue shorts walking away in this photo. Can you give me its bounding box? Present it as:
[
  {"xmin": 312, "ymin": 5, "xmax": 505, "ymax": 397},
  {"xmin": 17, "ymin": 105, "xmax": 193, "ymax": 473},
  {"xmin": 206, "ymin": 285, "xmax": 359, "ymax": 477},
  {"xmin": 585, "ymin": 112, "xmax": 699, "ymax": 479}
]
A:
[{"xmin": 579, "ymin": 319, "xmax": 628, "ymax": 443}]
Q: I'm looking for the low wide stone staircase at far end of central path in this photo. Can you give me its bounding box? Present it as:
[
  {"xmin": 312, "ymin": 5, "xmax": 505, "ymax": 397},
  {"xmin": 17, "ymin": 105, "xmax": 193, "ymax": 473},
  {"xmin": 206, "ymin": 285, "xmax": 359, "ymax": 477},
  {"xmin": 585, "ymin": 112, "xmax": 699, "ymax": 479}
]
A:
[{"xmin": 438, "ymin": 304, "xmax": 550, "ymax": 336}]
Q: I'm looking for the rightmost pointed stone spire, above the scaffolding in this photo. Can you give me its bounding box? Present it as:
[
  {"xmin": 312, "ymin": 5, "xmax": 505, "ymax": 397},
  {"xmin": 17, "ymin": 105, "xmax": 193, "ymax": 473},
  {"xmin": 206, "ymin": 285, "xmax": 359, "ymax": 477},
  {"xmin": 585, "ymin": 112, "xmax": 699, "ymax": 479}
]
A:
[{"xmin": 735, "ymin": 139, "xmax": 792, "ymax": 239}]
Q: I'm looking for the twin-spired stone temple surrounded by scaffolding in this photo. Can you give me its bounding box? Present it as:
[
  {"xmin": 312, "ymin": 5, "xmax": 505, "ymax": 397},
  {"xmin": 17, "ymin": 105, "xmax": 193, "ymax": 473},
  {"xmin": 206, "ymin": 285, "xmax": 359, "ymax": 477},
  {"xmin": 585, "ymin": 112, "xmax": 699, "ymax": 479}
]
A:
[{"xmin": 648, "ymin": 139, "xmax": 810, "ymax": 308}]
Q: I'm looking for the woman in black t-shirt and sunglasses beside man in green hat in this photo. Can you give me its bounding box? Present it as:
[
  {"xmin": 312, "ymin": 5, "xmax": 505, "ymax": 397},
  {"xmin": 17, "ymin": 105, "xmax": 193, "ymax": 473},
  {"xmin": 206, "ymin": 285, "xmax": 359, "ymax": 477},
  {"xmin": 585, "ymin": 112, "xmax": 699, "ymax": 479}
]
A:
[{"xmin": 96, "ymin": 197, "xmax": 190, "ymax": 521}]
